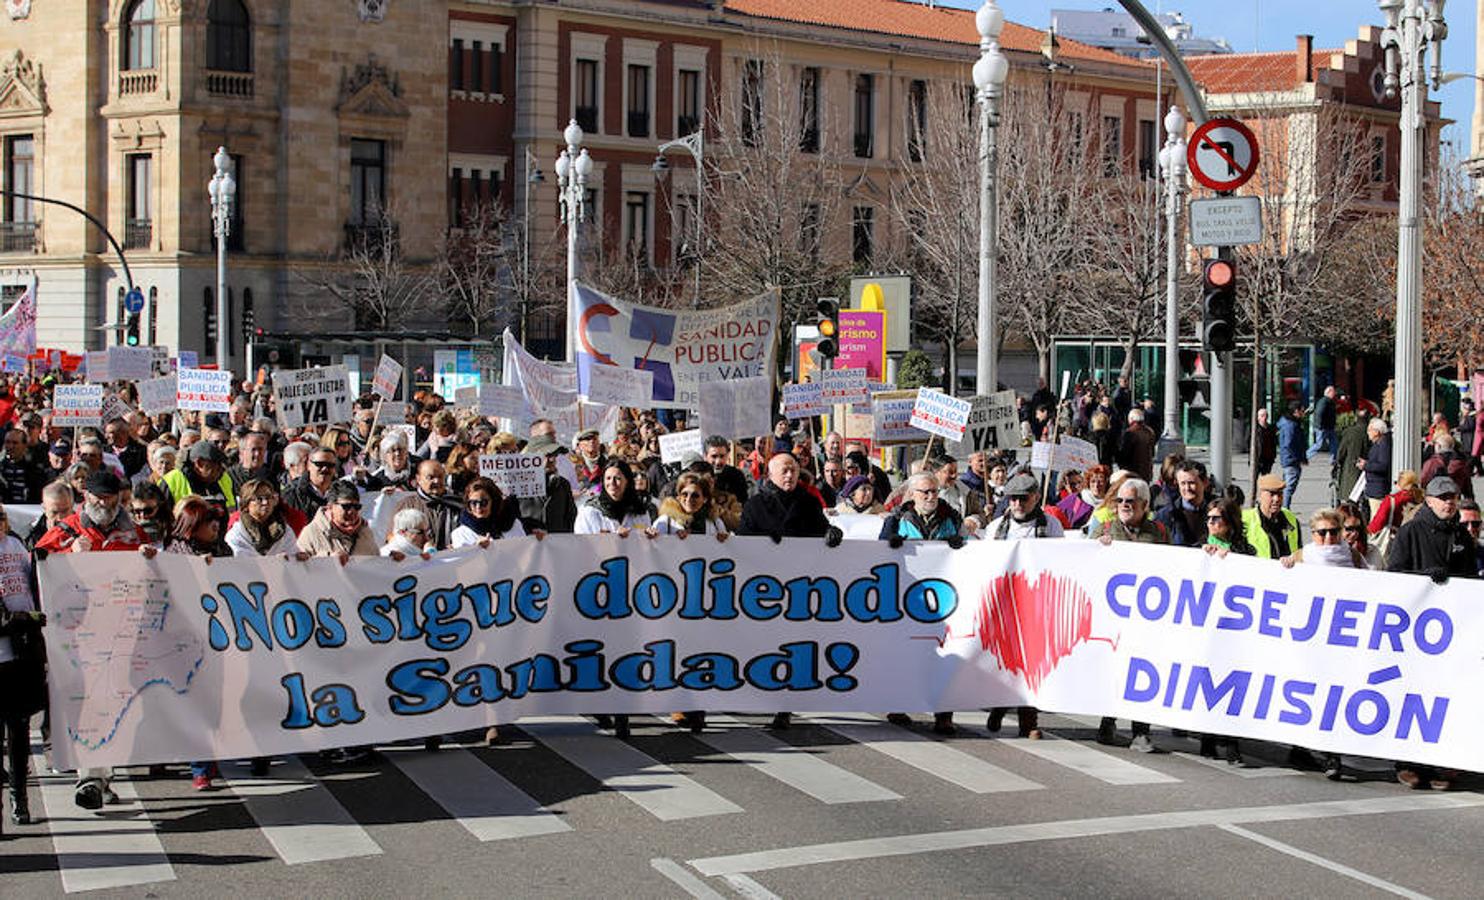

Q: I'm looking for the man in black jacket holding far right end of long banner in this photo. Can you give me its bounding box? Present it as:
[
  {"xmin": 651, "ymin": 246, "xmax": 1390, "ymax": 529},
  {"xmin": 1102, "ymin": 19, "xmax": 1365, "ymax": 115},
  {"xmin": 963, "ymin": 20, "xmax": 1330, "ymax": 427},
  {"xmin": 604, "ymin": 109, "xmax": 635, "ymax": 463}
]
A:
[{"xmin": 1386, "ymin": 475, "xmax": 1478, "ymax": 790}]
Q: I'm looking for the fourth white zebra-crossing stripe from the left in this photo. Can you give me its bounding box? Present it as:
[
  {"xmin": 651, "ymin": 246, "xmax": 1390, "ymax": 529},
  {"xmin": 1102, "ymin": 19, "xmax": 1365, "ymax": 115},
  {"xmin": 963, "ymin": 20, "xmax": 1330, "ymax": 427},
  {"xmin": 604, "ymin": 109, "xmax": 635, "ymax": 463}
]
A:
[{"xmin": 518, "ymin": 716, "xmax": 742, "ymax": 821}]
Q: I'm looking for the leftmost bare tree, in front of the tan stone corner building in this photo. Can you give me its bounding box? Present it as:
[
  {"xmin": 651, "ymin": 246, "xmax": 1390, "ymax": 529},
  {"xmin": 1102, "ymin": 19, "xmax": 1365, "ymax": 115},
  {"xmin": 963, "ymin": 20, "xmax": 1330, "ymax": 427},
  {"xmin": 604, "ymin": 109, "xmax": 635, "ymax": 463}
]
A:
[{"xmin": 295, "ymin": 201, "xmax": 438, "ymax": 331}]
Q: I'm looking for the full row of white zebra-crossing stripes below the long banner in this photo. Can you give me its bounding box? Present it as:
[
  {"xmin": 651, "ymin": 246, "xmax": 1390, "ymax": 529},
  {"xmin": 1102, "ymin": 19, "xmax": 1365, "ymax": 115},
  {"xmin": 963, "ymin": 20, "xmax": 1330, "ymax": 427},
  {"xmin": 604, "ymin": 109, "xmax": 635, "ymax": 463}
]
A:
[{"xmin": 8, "ymin": 713, "xmax": 1335, "ymax": 894}]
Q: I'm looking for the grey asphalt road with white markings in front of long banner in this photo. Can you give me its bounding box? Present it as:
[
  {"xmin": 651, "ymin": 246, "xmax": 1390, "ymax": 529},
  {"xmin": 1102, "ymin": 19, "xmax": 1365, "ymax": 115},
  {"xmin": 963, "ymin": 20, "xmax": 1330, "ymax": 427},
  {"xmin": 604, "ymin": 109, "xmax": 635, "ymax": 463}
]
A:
[{"xmin": 0, "ymin": 713, "xmax": 1484, "ymax": 899}]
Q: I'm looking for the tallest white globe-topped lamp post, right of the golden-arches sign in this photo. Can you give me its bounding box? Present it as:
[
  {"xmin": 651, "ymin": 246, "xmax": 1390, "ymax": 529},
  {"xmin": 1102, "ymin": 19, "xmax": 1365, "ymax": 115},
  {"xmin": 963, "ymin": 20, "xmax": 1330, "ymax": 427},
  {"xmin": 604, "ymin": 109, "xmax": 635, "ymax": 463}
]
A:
[{"xmin": 973, "ymin": 0, "xmax": 1011, "ymax": 395}]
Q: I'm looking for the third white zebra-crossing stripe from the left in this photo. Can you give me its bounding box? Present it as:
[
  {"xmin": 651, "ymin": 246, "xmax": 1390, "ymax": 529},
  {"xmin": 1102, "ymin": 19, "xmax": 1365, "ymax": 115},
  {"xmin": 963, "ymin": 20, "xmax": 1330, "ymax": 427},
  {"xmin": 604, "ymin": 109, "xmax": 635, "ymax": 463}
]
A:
[{"xmin": 380, "ymin": 744, "xmax": 571, "ymax": 841}]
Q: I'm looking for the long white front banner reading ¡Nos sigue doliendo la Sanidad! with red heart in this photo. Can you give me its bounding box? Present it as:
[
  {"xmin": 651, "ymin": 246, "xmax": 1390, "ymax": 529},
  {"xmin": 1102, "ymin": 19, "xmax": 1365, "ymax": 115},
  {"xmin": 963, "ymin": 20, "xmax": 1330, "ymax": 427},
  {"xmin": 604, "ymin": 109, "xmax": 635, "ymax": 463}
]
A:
[{"xmin": 37, "ymin": 535, "xmax": 1484, "ymax": 769}]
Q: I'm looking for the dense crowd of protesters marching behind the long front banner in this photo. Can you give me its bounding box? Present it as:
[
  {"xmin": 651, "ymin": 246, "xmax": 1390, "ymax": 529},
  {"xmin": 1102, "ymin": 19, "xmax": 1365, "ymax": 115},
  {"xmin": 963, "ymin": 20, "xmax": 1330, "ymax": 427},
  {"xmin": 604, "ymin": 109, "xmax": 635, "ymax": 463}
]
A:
[{"xmin": 0, "ymin": 366, "xmax": 1484, "ymax": 823}]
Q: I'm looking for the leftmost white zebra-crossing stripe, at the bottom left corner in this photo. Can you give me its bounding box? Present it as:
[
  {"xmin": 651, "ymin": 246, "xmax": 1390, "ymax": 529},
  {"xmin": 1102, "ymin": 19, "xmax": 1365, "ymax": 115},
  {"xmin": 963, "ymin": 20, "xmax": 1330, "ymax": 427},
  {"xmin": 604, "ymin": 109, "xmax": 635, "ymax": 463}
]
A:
[{"xmin": 31, "ymin": 753, "xmax": 175, "ymax": 894}]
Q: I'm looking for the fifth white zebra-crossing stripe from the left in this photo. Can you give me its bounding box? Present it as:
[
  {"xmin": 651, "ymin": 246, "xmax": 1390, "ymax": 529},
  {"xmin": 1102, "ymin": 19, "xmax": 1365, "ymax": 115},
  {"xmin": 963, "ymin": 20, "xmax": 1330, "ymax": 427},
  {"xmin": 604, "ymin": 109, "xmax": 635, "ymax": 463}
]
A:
[{"xmin": 696, "ymin": 714, "xmax": 902, "ymax": 803}]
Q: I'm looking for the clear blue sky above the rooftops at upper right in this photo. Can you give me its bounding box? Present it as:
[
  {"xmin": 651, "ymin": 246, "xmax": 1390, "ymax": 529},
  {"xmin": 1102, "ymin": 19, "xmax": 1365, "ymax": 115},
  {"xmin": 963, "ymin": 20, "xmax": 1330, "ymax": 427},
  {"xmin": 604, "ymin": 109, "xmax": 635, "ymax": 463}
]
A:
[{"xmin": 947, "ymin": 0, "xmax": 1484, "ymax": 156}]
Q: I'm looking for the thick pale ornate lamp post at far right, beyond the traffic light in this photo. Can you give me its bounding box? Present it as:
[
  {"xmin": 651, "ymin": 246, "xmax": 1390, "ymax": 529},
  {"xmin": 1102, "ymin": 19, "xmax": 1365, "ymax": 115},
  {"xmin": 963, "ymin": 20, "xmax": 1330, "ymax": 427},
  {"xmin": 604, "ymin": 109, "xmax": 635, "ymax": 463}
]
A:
[{"xmin": 1380, "ymin": 0, "xmax": 1448, "ymax": 480}]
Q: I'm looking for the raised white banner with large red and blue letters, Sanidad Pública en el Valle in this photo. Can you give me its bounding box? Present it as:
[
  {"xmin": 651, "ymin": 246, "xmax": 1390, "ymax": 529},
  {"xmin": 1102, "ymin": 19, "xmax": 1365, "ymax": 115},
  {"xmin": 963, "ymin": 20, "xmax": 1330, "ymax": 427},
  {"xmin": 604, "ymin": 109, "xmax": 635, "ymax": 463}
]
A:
[{"xmin": 571, "ymin": 284, "xmax": 779, "ymax": 410}]
